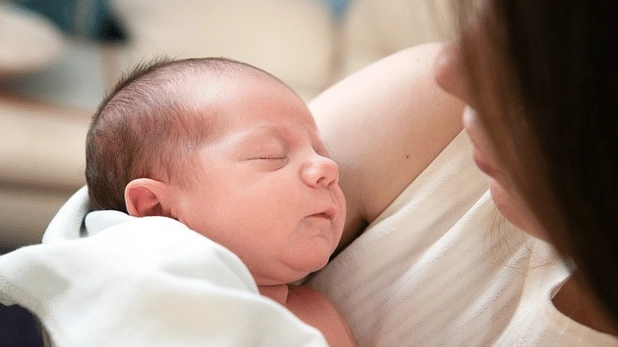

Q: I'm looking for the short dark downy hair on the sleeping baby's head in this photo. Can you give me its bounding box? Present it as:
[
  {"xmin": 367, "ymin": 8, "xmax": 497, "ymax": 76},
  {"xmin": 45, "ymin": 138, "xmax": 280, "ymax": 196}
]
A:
[{"xmin": 85, "ymin": 57, "xmax": 285, "ymax": 212}]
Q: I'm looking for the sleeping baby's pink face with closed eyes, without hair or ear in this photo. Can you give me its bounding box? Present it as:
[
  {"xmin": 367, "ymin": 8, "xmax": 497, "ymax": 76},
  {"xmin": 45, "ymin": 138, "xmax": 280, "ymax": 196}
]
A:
[{"xmin": 174, "ymin": 78, "xmax": 345, "ymax": 285}]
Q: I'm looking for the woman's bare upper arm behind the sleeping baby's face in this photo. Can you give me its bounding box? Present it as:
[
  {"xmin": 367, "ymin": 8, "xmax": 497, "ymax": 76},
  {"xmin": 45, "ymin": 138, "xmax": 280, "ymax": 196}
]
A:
[{"xmin": 309, "ymin": 44, "xmax": 463, "ymax": 250}]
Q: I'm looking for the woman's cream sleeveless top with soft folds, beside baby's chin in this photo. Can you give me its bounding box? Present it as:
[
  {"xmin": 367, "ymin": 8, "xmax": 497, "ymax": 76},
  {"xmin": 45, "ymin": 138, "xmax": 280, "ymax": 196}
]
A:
[{"xmin": 309, "ymin": 134, "xmax": 618, "ymax": 347}]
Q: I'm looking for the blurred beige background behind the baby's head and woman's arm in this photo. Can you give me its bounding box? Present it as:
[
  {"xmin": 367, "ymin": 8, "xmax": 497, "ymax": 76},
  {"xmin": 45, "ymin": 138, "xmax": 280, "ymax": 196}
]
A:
[{"xmin": 0, "ymin": 0, "xmax": 452, "ymax": 254}]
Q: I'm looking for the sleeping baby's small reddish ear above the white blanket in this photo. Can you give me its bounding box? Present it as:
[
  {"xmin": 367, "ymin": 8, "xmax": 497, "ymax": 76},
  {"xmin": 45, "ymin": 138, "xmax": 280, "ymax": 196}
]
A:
[{"xmin": 124, "ymin": 178, "xmax": 171, "ymax": 217}]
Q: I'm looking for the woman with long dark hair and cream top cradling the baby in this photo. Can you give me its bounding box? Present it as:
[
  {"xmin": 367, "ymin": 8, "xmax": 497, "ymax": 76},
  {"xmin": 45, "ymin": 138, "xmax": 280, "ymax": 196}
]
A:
[{"xmin": 312, "ymin": 0, "xmax": 618, "ymax": 346}]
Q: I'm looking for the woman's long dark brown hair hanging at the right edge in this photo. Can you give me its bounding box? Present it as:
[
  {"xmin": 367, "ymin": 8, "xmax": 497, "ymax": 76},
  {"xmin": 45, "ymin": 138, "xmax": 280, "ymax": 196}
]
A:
[{"xmin": 458, "ymin": 0, "xmax": 618, "ymax": 321}]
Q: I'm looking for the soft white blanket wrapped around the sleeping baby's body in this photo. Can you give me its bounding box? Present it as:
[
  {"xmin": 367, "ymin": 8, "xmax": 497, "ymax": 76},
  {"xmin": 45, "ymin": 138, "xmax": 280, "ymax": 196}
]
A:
[{"xmin": 0, "ymin": 189, "xmax": 326, "ymax": 347}]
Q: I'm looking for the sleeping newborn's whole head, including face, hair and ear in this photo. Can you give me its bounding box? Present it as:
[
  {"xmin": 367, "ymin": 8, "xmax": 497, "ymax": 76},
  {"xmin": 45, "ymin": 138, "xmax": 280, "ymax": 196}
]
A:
[{"xmin": 86, "ymin": 58, "xmax": 345, "ymax": 285}]
